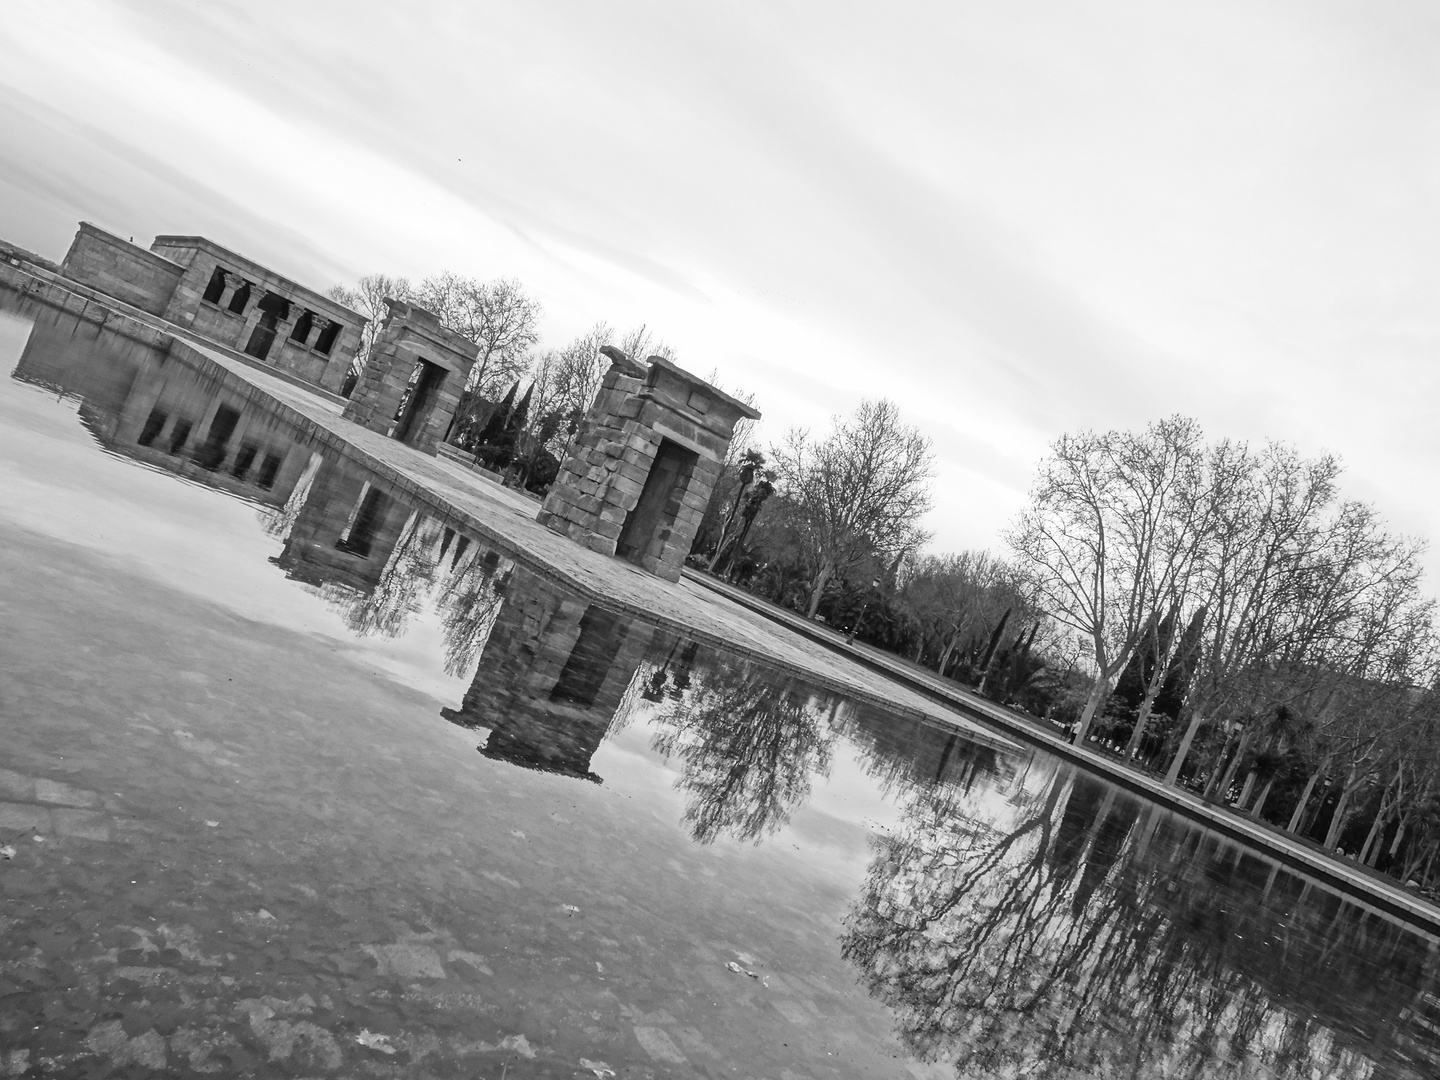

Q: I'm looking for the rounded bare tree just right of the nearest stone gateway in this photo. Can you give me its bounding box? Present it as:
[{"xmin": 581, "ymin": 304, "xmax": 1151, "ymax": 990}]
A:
[{"xmin": 770, "ymin": 399, "xmax": 935, "ymax": 618}]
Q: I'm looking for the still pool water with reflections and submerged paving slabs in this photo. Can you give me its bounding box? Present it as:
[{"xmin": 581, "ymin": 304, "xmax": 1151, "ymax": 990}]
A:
[{"xmin": 0, "ymin": 294, "xmax": 1440, "ymax": 1080}]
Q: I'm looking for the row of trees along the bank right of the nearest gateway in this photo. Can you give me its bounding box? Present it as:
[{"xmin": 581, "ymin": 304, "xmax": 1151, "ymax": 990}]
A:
[{"xmin": 694, "ymin": 402, "xmax": 1440, "ymax": 890}]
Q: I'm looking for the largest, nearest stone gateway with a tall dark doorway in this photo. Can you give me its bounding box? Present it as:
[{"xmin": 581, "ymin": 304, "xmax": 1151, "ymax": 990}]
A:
[{"xmin": 540, "ymin": 346, "xmax": 760, "ymax": 582}]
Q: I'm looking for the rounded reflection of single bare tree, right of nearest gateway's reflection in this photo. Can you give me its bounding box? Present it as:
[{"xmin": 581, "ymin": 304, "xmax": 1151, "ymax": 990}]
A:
[{"xmin": 651, "ymin": 657, "xmax": 840, "ymax": 844}]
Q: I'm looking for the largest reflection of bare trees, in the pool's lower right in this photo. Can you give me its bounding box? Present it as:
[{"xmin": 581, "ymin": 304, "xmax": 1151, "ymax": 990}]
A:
[{"xmin": 841, "ymin": 768, "xmax": 1426, "ymax": 1080}]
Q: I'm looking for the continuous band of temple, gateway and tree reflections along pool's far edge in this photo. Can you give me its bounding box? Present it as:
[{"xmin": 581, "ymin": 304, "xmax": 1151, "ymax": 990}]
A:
[{"xmin": 13, "ymin": 292, "xmax": 1440, "ymax": 1080}]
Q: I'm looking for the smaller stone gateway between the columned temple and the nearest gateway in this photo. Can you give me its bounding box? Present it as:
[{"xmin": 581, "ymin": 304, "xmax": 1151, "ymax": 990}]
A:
[{"xmin": 344, "ymin": 298, "xmax": 480, "ymax": 454}]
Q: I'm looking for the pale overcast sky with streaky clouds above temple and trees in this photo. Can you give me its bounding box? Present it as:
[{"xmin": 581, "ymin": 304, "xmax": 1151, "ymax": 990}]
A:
[{"xmin": 0, "ymin": 0, "xmax": 1440, "ymax": 590}]
